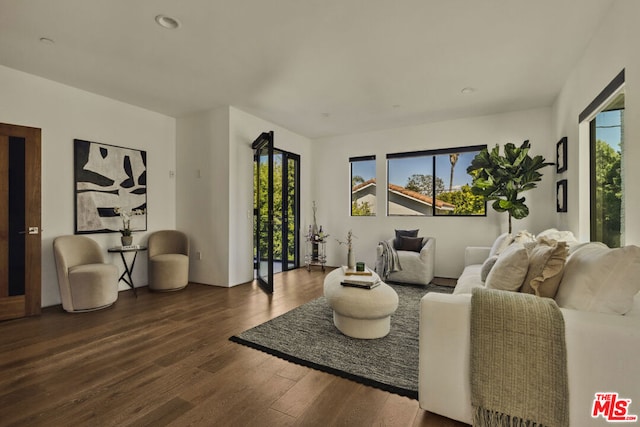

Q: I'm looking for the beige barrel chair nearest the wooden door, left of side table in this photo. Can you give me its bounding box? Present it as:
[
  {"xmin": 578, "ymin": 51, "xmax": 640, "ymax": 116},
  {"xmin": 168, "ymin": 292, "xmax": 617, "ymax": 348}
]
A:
[{"xmin": 53, "ymin": 236, "xmax": 118, "ymax": 313}]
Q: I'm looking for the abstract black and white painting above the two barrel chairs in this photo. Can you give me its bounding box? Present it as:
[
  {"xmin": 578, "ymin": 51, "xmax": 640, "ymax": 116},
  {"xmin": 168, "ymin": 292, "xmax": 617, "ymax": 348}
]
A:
[{"xmin": 73, "ymin": 139, "xmax": 147, "ymax": 234}]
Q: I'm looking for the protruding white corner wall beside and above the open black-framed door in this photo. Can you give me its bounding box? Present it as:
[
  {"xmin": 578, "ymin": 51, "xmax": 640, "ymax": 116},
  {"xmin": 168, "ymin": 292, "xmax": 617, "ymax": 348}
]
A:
[{"xmin": 177, "ymin": 107, "xmax": 311, "ymax": 286}]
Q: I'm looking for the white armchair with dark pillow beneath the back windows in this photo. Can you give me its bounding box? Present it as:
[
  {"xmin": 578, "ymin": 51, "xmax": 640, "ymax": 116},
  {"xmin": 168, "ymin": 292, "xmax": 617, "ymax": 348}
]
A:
[{"xmin": 376, "ymin": 237, "xmax": 436, "ymax": 285}]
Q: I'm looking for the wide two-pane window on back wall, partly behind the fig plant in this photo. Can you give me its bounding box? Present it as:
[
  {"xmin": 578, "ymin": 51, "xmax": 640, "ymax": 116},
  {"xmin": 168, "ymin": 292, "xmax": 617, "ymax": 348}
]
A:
[{"xmin": 387, "ymin": 145, "xmax": 486, "ymax": 216}]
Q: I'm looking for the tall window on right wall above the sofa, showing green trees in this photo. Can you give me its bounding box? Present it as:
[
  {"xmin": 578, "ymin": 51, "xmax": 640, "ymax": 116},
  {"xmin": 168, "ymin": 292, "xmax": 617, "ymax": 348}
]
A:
[{"xmin": 580, "ymin": 71, "xmax": 625, "ymax": 248}]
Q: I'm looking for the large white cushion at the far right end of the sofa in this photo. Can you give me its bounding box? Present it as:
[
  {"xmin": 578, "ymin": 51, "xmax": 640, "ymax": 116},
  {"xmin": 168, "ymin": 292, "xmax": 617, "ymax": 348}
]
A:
[{"xmin": 556, "ymin": 242, "xmax": 640, "ymax": 314}]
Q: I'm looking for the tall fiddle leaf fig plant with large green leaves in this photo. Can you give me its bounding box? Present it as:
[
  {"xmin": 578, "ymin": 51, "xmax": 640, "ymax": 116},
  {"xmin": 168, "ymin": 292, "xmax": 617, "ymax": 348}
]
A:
[{"xmin": 467, "ymin": 140, "xmax": 553, "ymax": 233}]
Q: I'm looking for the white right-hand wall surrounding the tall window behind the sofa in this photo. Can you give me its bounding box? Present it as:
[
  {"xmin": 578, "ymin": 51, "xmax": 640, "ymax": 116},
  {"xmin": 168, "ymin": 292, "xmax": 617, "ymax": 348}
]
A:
[{"xmin": 552, "ymin": 1, "xmax": 640, "ymax": 245}]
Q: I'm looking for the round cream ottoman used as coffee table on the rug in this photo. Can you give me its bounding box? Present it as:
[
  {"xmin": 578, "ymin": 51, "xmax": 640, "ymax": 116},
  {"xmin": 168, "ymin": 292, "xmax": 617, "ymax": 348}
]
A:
[{"xmin": 324, "ymin": 268, "xmax": 398, "ymax": 339}]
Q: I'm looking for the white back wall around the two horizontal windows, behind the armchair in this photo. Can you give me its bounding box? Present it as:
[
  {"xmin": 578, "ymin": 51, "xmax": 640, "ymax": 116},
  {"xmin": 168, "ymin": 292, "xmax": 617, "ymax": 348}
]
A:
[{"xmin": 312, "ymin": 108, "xmax": 555, "ymax": 277}]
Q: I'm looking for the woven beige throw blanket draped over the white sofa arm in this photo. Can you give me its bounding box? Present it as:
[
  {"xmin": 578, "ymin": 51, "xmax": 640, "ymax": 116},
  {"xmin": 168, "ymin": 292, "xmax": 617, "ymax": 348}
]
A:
[{"xmin": 471, "ymin": 288, "xmax": 569, "ymax": 427}]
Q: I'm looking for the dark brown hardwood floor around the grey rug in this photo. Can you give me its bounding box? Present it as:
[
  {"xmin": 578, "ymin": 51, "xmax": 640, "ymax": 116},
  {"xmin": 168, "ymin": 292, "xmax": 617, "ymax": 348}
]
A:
[{"xmin": 0, "ymin": 269, "xmax": 465, "ymax": 426}]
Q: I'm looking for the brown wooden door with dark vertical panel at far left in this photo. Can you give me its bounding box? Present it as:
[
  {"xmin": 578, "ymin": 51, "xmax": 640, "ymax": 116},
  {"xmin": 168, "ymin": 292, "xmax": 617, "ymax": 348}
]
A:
[{"xmin": 0, "ymin": 123, "xmax": 41, "ymax": 320}]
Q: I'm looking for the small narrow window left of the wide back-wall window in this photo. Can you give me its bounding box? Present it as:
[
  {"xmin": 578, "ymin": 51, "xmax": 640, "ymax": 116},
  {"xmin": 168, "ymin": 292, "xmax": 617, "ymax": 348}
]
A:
[{"xmin": 349, "ymin": 156, "xmax": 376, "ymax": 216}]
